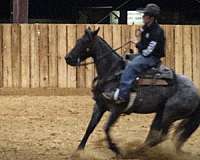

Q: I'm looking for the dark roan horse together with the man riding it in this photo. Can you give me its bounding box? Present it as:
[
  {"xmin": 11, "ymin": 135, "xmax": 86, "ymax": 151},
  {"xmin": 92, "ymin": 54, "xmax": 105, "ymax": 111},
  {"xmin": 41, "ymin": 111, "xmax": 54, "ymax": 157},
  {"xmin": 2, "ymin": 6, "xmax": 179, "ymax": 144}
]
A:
[{"xmin": 65, "ymin": 4, "xmax": 200, "ymax": 155}]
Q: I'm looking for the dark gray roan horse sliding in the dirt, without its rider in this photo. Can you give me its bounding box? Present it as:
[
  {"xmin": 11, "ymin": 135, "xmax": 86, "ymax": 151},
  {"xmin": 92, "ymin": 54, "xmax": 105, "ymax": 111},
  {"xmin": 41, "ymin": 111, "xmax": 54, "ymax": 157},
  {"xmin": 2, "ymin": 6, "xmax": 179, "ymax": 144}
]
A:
[{"xmin": 65, "ymin": 28, "xmax": 200, "ymax": 155}]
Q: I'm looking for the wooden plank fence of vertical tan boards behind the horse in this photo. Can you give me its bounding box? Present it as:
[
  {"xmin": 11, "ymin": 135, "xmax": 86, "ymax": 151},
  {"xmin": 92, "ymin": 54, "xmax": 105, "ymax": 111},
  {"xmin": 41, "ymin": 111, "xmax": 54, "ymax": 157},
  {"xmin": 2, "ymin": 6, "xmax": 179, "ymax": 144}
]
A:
[{"xmin": 0, "ymin": 24, "xmax": 200, "ymax": 88}]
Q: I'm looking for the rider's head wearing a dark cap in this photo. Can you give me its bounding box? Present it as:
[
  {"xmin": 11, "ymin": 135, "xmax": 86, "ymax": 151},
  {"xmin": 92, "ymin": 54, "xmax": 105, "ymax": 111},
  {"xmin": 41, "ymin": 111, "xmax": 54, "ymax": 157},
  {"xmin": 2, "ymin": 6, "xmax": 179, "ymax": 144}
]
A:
[{"xmin": 143, "ymin": 3, "xmax": 160, "ymax": 25}]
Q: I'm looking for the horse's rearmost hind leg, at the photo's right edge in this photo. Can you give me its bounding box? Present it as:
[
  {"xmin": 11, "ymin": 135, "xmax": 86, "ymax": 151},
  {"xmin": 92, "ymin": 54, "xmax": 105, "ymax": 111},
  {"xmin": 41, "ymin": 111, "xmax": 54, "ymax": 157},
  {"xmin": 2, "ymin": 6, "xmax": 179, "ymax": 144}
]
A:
[{"xmin": 173, "ymin": 112, "xmax": 200, "ymax": 152}]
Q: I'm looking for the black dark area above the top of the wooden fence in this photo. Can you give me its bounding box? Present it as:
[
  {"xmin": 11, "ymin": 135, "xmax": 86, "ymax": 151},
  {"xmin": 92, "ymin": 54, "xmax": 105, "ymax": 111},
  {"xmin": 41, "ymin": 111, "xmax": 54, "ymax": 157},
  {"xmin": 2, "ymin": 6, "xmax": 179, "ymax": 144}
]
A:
[{"xmin": 0, "ymin": 0, "xmax": 200, "ymax": 24}]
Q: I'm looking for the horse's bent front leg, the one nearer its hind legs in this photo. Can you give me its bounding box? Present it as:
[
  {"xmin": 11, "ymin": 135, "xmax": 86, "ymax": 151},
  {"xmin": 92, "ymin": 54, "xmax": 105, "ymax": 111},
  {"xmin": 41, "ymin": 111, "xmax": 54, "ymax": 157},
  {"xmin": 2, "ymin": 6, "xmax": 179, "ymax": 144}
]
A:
[{"xmin": 104, "ymin": 106, "xmax": 121, "ymax": 155}]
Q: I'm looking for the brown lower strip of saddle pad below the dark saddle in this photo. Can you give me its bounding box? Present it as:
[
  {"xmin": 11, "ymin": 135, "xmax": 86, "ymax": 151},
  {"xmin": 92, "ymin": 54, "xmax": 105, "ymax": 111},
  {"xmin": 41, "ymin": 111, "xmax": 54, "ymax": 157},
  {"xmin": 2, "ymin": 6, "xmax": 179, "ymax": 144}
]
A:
[{"xmin": 137, "ymin": 79, "xmax": 168, "ymax": 86}]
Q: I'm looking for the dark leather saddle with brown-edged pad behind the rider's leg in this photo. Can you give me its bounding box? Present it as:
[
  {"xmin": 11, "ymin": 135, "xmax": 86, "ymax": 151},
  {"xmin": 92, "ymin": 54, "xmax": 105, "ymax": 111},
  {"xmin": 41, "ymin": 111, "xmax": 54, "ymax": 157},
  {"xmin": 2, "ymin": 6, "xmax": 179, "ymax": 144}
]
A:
[{"xmin": 136, "ymin": 63, "xmax": 174, "ymax": 86}]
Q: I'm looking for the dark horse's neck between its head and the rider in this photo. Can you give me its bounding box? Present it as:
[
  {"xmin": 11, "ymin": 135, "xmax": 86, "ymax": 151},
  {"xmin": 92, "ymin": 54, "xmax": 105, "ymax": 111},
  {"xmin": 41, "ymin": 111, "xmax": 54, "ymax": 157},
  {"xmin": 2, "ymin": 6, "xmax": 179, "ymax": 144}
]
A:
[{"xmin": 94, "ymin": 38, "xmax": 122, "ymax": 78}]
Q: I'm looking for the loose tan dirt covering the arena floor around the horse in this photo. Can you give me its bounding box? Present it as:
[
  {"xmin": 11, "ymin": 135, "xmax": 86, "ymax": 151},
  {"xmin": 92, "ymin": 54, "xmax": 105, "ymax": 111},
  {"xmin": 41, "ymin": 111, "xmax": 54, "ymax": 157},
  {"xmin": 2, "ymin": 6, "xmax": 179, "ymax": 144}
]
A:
[{"xmin": 0, "ymin": 96, "xmax": 200, "ymax": 160}]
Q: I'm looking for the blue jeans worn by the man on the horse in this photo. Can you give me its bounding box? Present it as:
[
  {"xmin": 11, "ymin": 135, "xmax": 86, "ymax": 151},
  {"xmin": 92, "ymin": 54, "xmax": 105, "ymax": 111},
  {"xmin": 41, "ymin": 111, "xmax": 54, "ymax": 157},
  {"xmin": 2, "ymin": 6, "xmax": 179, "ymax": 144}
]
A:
[{"xmin": 119, "ymin": 54, "xmax": 160, "ymax": 100}]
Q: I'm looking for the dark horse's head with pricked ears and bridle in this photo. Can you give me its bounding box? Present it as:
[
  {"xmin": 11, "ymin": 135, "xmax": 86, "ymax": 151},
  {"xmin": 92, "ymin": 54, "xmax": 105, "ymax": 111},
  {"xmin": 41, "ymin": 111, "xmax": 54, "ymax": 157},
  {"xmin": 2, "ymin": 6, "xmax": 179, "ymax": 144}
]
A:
[{"xmin": 65, "ymin": 28, "xmax": 100, "ymax": 66}]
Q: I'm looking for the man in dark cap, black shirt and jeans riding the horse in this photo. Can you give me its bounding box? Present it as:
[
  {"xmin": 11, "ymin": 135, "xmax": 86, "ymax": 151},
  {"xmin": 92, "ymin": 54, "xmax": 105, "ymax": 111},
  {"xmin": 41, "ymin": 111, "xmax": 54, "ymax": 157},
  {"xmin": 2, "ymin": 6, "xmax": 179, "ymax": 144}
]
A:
[{"xmin": 103, "ymin": 3, "xmax": 165, "ymax": 103}]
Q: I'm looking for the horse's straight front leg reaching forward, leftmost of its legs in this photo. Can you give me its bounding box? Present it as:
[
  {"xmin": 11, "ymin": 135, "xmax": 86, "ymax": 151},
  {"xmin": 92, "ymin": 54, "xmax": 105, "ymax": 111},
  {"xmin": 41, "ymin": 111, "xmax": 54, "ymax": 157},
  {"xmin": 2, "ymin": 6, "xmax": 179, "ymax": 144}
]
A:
[{"xmin": 78, "ymin": 104, "xmax": 105, "ymax": 150}]
